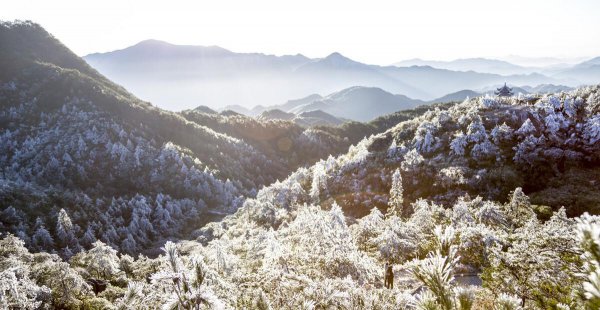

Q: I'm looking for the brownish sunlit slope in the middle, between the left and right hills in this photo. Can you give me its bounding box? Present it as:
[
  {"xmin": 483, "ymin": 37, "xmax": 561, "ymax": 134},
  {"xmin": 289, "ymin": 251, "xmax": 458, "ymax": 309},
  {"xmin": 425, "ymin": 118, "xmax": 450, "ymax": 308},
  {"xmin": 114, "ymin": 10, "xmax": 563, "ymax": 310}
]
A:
[{"xmin": 180, "ymin": 103, "xmax": 454, "ymax": 178}]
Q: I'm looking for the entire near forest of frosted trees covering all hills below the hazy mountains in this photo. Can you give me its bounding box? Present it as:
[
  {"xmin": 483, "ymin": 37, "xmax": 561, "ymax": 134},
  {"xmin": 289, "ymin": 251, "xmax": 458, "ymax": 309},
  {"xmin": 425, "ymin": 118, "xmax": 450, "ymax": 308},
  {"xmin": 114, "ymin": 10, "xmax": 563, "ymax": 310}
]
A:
[{"xmin": 0, "ymin": 22, "xmax": 600, "ymax": 310}]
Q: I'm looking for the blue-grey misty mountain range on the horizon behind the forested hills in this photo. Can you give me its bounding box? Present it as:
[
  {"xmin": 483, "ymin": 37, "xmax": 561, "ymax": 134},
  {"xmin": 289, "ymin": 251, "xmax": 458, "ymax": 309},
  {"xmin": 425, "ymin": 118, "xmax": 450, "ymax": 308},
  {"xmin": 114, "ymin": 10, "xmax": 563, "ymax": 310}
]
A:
[{"xmin": 84, "ymin": 40, "xmax": 600, "ymax": 110}]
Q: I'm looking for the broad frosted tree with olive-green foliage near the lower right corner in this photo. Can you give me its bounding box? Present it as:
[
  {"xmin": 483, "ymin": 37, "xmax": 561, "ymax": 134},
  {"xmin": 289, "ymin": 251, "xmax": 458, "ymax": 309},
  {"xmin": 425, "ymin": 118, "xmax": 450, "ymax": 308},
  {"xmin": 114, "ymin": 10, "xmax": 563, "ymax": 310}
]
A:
[{"xmin": 483, "ymin": 209, "xmax": 581, "ymax": 308}]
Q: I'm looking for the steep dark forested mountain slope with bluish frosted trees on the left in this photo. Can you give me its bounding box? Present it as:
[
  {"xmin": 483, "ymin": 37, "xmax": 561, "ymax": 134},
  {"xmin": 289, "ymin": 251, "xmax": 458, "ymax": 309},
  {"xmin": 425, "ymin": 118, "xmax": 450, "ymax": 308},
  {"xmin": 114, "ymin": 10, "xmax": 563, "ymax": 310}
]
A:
[{"xmin": 0, "ymin": 22, "xmax": 302, "ymax": 256}]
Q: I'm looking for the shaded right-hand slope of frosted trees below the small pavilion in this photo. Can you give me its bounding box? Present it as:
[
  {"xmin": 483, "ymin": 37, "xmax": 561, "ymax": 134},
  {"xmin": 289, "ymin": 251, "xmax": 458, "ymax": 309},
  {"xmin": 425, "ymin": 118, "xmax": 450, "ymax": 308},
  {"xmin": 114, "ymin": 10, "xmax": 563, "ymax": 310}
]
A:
[{"xmin": 231, "ymin": 86, "xmax": 600, "ymax": 217}]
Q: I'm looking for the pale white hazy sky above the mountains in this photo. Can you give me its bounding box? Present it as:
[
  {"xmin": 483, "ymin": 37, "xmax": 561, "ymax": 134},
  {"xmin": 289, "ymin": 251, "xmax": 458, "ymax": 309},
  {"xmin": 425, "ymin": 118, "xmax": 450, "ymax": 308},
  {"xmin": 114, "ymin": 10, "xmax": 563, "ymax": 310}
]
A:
[{"xmin": 0, "ymin": 0, "xmax": 600, "ymax": 64}]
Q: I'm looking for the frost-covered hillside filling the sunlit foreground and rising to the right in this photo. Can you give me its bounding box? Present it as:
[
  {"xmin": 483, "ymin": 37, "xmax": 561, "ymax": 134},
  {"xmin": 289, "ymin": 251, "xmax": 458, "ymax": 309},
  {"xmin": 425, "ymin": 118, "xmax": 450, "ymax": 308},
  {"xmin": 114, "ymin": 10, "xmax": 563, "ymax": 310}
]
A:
[{"xmin": 0, "ymin": 86, "xmax": 600, "ymax": 309}]
